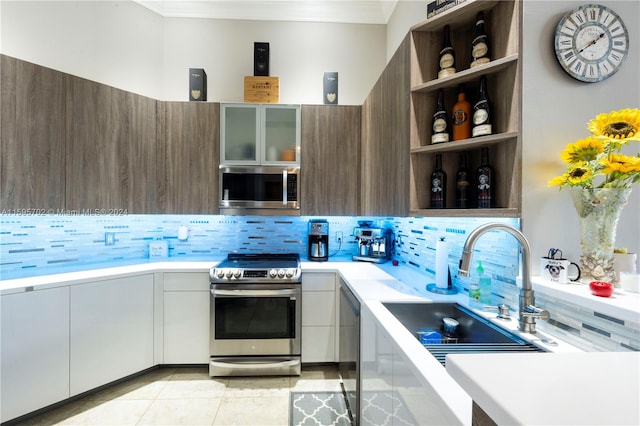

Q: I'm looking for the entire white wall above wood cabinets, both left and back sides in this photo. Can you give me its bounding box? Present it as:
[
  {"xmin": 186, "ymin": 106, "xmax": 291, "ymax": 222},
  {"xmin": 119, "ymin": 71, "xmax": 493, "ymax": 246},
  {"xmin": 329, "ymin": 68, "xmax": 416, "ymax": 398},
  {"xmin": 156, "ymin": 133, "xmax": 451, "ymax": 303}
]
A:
[{"xmin": 0, "ymin": 0, "xmax": 386, "ymax": 105}]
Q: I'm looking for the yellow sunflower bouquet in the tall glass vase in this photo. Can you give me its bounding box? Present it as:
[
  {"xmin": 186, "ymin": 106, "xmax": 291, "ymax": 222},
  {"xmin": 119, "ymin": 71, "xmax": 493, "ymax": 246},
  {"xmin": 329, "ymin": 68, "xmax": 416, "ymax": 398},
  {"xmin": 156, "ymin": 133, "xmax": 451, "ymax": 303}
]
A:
[{"xmin": 549, "ymin": 108, "xmax": 640, "ymax": 188}]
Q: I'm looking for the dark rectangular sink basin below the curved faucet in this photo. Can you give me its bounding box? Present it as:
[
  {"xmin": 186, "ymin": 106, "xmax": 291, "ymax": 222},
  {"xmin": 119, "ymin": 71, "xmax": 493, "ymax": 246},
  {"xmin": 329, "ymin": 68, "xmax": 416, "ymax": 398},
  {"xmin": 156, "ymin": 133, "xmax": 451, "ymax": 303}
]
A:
[{"xmin": 383, "ymin": 302, "xmax": 544, "ymax": 365}]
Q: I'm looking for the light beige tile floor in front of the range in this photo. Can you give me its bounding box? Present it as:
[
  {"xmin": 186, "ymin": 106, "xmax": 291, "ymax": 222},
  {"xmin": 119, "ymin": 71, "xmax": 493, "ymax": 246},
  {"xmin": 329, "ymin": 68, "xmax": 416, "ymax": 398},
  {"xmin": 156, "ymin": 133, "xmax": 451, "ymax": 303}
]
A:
[{"xmin": 20, "ymin": 365, "xmax": 341, "ymax": 426}]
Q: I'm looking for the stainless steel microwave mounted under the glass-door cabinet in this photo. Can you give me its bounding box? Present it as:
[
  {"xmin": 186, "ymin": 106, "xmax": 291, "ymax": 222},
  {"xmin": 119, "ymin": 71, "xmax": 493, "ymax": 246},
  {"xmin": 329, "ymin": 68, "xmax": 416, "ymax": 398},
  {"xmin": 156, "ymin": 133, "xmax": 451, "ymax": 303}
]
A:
[{"xmin": 218, "ymin": 165, "xmax": 300, "ymax": 216}]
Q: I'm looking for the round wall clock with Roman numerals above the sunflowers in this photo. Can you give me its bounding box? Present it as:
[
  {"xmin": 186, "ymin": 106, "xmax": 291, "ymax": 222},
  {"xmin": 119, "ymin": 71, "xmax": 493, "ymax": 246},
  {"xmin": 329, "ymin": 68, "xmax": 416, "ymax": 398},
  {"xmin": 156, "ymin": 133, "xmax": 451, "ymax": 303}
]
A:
[{"xmin": 554, "ymin": 4, "xmax": 629, "ymax": 83}]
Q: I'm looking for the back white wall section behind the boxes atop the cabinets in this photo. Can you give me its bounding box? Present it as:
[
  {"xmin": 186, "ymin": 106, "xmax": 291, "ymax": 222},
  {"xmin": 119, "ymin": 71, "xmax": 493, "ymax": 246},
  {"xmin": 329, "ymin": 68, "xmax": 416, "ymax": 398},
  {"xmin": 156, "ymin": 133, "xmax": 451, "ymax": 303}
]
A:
[{"xmin": 163, "ymin": 19, "xmax": 386, "ymax": 105}]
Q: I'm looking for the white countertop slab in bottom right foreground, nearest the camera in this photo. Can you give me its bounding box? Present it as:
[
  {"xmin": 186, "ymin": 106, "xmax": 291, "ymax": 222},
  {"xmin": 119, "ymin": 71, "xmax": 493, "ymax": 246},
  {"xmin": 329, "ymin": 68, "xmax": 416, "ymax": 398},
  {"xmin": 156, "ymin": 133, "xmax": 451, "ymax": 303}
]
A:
[{"xmin": 447, "ymin": 352, "xmax": 640, "ymax": 425}]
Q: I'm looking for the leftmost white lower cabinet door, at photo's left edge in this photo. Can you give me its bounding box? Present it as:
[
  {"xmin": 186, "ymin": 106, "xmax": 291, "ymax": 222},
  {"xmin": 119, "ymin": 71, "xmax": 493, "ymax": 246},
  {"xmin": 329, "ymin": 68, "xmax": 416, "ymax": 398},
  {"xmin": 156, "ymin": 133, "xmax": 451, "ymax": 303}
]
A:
[{"xmin": 0, "ymin": 287, "xmax": 69, "ymax": 422}]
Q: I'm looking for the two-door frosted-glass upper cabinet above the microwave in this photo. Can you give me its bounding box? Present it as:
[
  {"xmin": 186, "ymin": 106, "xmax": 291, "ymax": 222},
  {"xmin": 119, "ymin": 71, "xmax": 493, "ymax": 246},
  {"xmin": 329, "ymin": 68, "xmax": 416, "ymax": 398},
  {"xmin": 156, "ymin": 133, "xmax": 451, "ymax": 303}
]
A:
[{"xmin": 220, "ymin": 103, "xmax": 300, "ymax": 165}]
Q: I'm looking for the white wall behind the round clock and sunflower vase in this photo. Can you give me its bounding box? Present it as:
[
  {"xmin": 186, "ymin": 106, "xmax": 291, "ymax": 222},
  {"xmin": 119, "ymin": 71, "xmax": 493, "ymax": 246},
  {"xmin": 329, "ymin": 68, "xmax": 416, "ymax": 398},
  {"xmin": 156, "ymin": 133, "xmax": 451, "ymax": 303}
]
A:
[{"xmin": 522, "ymin": 0, "xmax": 640, "ymax": 265}]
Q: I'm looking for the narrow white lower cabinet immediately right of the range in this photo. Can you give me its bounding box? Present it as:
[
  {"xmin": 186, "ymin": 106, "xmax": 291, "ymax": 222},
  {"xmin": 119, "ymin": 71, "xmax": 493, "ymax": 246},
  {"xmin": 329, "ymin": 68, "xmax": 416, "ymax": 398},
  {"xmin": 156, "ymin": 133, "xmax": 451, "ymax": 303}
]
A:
[{"xmin": 302, "ymin": 271, "xmax": 338, "ymax": 363}]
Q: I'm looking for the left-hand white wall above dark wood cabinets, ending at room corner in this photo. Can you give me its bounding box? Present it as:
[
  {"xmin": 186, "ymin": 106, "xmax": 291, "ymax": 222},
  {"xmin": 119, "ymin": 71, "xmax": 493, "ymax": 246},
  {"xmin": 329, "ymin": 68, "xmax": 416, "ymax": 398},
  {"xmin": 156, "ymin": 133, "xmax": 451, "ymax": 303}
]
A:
[{"xmin": 0, "ymin": 1, "xmax": 165, "ymax": 98}]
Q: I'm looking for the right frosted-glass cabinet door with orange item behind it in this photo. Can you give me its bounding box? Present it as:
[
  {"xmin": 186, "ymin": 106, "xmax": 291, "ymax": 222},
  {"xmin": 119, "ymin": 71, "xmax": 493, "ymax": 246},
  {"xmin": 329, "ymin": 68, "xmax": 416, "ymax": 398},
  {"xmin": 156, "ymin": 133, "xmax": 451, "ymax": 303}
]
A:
[{"xmin": 261, "ymin": 105, "xmax": 300, "ymax": 164}]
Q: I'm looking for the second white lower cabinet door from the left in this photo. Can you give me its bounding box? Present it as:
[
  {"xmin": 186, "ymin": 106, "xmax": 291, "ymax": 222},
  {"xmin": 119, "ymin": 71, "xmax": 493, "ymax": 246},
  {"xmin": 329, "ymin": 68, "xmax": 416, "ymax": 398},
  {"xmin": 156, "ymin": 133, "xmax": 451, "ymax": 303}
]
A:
[{"xmin": 70, "ymin": 274, "xmax": 154, "ymax": 396}]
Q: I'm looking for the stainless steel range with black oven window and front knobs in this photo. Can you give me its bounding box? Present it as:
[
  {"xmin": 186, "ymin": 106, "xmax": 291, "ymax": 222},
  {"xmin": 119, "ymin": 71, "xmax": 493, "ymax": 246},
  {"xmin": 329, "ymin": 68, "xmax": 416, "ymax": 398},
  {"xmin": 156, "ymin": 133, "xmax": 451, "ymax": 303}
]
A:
[{"xmin": 209, "ymin": 254, "xmax": 302, "ymax": 376}]
